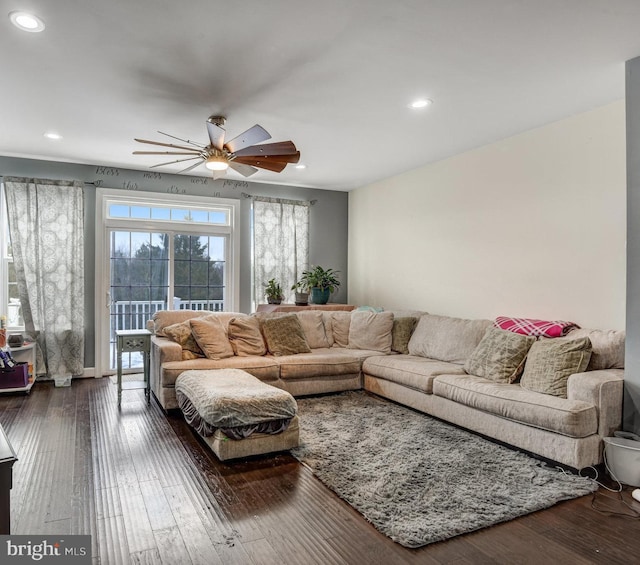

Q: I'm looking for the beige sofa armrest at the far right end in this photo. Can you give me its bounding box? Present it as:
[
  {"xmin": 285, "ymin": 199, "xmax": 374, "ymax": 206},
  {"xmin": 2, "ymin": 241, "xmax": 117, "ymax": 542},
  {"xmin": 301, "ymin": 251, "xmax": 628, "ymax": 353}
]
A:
[{"xmin": 567, "ymin": 369, "xmax": 624, "ymax": 437}]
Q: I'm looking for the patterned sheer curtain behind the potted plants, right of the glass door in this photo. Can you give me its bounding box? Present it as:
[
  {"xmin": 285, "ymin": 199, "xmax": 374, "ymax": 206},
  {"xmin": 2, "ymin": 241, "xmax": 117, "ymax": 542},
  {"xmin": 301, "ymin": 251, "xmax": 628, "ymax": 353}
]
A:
[{"xmin": 253, "ymin": 197, "xmax": 310, "ymax": 304}]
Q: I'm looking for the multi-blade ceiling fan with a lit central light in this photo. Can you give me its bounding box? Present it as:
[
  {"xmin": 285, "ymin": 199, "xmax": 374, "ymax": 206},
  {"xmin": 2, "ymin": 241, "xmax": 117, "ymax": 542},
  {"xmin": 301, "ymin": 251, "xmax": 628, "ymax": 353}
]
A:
[{"xmin": 133, "ymin": 116, "xmax": 300, "ymax": 179}]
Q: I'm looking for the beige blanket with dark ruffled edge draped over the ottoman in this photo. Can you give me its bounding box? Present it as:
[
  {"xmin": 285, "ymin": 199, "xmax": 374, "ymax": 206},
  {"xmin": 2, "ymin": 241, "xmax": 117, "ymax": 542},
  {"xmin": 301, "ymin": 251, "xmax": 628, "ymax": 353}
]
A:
[{"xmin": 175, "ymin": 369, "xmax": 298, "ymax": 439}]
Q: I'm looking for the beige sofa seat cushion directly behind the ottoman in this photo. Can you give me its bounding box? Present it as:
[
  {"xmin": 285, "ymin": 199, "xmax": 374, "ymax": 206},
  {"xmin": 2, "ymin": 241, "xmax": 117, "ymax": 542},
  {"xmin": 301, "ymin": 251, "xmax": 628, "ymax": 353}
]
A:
[{"xmin": 160, "ymin": 355, "xmax": 280, "ymax": 387}]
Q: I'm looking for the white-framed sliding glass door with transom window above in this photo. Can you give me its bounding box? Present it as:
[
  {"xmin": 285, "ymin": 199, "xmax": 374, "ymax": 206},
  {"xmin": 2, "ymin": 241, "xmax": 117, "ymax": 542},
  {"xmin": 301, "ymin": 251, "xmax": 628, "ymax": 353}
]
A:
[{"xmin": 96, "ymin": 189, "xmax": 239, "ymax": 372}]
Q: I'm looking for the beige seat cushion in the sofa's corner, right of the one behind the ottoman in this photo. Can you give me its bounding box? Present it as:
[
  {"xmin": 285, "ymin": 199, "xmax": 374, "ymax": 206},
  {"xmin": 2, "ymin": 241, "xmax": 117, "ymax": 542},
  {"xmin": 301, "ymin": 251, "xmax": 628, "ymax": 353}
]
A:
[{"xmin": 274, "ymin": 348, "xmax": 362, "ymax": 380}]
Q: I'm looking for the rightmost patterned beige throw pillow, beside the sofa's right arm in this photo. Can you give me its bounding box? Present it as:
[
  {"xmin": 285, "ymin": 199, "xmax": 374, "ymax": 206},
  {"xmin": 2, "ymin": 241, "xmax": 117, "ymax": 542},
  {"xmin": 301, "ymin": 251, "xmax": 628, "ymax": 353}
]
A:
[{"xmin": 520, "ymin": 337, "xmax": 591, "ymax": 398}]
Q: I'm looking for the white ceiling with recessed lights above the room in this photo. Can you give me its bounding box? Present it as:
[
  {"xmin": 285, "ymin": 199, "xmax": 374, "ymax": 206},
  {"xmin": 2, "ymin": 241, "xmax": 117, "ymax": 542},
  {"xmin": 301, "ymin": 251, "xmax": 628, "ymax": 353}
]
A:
[{"xmin": 0, "ymin": 0, "xmax": 640, "ymax": 190}]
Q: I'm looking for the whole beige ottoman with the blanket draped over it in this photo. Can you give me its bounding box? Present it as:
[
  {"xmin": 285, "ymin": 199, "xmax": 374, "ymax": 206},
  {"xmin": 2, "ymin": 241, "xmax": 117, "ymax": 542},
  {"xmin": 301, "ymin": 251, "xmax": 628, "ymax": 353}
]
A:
[{"xmin": 175, "ymin": 369, "xmax": 299, "ymax": 461}]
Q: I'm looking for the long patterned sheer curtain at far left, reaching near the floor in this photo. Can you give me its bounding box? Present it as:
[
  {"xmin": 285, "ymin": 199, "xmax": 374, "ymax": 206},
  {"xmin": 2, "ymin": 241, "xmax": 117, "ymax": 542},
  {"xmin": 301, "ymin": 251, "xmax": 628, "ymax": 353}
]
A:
[{"xmin": 4, "ymin": 177, "xmax": 84, "ymax": 378}]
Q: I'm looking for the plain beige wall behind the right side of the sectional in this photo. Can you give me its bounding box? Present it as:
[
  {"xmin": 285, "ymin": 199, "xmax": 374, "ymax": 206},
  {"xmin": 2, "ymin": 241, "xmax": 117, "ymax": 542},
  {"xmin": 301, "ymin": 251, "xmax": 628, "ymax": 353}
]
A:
[{"xmin": 349, "ymin": 101, "xmax": 626, "ymax": 329}]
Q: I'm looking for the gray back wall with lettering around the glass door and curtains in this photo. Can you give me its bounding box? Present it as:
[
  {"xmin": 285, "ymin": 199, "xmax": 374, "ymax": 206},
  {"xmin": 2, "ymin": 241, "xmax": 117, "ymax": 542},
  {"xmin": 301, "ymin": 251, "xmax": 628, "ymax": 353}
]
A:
[{"xmin": 0, "ymin": 156, "xmax": 348, "ymax": 367}]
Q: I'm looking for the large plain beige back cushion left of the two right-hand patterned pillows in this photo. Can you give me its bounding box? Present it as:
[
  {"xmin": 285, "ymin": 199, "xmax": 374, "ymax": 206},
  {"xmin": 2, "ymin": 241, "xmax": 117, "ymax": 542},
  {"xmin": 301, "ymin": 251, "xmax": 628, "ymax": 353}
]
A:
[{"xmin": 409, "ymin": 314, "xmax": 493, "ymax": 365}]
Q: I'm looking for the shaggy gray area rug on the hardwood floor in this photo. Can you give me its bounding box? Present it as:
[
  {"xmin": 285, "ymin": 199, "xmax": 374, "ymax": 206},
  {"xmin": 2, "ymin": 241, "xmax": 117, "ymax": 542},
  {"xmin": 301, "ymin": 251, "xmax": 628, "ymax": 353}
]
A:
[{"xmin": 291, "ymin": 391, "xmax": 597, "ymax": 547}]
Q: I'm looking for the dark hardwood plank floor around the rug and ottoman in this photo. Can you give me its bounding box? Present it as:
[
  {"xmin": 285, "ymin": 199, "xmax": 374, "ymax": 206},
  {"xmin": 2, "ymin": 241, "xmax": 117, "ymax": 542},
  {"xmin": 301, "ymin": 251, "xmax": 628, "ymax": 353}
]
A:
[{"xmin": 0, "ymin": 378, "xmax": 640, "ymax": 565}]
